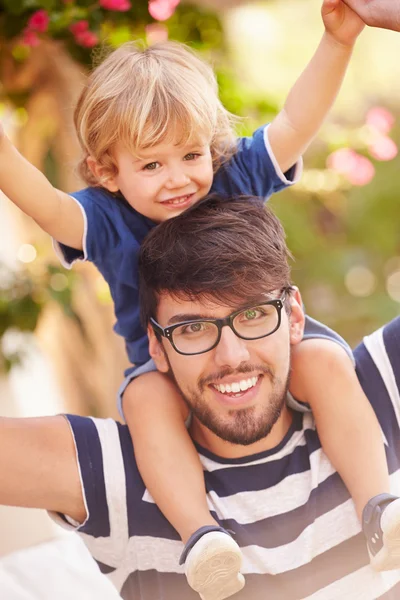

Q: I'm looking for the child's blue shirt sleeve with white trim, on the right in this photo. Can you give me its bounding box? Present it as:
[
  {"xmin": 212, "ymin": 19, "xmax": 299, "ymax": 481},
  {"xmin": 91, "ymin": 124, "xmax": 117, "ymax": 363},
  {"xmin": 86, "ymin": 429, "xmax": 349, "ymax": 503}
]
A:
[{"xmin": 212, "ymin": 126, "xmax": 303, "ymax": 199}]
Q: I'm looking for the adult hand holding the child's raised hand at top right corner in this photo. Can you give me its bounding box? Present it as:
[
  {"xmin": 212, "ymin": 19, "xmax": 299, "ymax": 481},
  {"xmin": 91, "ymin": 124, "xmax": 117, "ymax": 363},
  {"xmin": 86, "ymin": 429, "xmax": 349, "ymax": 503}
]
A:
[{"xmin": 344, "ymin": 0, "xmax": 400, "ymax": 31}]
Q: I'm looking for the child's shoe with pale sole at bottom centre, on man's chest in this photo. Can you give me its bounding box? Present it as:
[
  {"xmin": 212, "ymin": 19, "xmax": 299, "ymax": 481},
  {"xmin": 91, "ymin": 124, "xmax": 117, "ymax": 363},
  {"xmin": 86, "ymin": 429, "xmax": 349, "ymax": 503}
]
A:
[{"xmin": 180, "ymin": 526, "xmax": 245, "ymax": 600}]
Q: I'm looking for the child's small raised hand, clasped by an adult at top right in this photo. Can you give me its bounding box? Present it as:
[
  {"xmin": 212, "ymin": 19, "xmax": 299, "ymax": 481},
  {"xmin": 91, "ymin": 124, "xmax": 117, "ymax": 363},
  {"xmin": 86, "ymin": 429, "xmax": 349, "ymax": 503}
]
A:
[{"xmin": 321, "ymin": 0, "xmax": 366, "ymax": 46}]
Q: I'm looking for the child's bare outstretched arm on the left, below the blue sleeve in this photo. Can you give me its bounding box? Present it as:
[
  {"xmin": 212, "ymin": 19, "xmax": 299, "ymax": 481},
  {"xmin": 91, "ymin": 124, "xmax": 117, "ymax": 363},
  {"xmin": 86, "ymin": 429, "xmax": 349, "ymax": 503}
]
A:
[{"xmin": 0, "ymin": 125, "xmax": 84, "ymax": 250}]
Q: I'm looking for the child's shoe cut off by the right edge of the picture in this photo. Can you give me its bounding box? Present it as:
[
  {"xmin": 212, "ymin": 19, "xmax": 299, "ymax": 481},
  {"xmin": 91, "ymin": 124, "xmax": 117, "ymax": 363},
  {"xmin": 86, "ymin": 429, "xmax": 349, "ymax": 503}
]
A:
[{"xmin": 362, "ymin": 494, "xmax": 400, "ymax": 571}]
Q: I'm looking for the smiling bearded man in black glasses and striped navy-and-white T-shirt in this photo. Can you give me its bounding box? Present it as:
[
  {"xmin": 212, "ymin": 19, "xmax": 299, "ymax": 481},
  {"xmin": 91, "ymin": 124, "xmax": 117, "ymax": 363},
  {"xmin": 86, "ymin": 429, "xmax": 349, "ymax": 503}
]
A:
[{"xmin": 0, "ymin": 199, "xmax": 400, "ymax": 600}]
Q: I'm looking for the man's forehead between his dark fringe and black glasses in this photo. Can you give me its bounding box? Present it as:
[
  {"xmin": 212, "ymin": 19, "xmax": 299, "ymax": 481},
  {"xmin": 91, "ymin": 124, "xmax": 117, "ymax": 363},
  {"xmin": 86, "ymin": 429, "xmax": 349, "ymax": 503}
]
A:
[{"xmin": 156, "ymin": 290, "xmax": 279, "ymax": 327}]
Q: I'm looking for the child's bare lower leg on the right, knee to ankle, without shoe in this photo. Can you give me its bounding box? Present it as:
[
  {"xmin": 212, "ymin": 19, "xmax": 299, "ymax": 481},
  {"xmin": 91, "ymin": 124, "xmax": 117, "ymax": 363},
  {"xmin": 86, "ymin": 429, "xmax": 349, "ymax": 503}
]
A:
[{"xmin": 290, "ymin": 339, "xmax": 390, "ymax": 520}]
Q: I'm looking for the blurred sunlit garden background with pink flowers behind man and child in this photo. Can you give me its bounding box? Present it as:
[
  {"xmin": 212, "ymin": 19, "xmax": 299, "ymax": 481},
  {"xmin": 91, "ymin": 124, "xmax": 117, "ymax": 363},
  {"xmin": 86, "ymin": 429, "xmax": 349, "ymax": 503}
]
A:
[{"xmin": 0, "ymin": 0, "xmax": 400, "ymax": 597}]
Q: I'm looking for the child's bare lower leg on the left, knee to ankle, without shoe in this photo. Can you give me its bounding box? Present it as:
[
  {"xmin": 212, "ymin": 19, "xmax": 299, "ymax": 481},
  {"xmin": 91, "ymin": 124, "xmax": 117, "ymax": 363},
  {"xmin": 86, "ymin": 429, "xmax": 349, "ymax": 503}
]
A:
[{"xmin": 123, "ymin": 371, "xmax": 218, "ymax": 544}]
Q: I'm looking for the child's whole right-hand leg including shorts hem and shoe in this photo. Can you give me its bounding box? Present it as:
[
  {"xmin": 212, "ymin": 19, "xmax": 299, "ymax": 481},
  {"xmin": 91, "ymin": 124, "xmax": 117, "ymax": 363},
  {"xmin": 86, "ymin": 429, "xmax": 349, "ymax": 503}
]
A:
[{"xmin": 291, "ymin": 320, "xmax": 400, "ymax": 570}]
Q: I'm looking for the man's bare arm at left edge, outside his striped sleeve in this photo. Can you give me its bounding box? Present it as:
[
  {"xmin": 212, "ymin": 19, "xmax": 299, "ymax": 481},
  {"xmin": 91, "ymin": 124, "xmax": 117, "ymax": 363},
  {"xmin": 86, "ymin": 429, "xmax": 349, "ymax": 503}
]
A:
[{"xmin": 0, "ymin": 416, "xmax": 86, "ymax": 523}]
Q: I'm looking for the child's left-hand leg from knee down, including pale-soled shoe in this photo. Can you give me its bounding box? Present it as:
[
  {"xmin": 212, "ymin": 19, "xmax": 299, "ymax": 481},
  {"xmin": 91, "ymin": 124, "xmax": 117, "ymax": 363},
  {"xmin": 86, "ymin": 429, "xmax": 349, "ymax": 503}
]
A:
[{"xmin": 123, "ymin": 371, "xmax": 244, "ymax": 600}]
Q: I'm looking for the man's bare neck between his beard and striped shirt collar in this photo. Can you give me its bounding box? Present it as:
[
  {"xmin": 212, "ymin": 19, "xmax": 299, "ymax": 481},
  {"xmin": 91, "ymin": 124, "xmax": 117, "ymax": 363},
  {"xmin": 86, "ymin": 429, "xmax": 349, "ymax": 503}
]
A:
[{"xmin": 190, "ymin": 405, "xmax": 293, "ymax": 458}]
